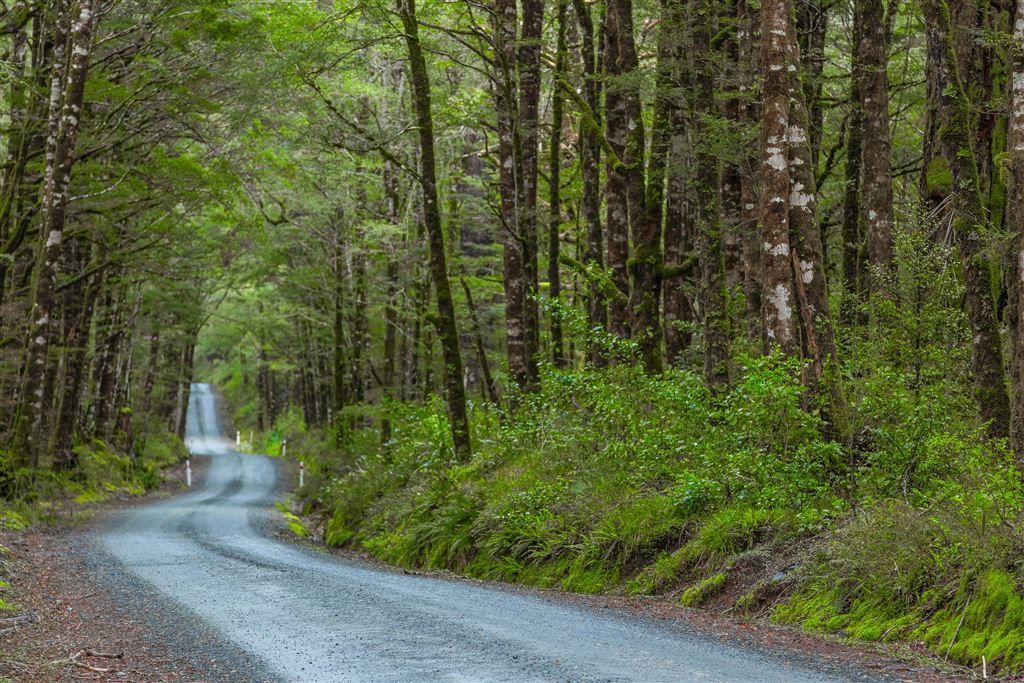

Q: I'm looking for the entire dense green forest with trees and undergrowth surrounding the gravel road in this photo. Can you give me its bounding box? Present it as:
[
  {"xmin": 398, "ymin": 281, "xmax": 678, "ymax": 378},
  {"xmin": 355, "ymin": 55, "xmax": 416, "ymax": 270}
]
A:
[{"xmin": 6, "ymin": 0, "xmax": 1024, "ymax": 672}]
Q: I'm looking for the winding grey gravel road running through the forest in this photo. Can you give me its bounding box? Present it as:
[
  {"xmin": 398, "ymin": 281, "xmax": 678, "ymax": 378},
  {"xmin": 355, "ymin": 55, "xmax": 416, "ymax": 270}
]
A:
[{"xmin": 100, "ymin": 384, "xmax": 863, "ymax": 682}]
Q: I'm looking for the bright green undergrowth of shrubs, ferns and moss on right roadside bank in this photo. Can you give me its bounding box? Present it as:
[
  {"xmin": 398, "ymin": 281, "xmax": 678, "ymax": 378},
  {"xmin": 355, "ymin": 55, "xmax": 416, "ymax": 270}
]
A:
[{"xmin": 220, "ymin": 229, "xmax": 1024, "ymax": 673}]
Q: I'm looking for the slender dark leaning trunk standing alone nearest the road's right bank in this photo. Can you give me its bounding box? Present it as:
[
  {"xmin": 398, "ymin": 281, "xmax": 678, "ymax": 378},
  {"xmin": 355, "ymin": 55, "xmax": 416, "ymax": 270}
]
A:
[{"xmin": 399, "ymin": 0, "xmax": 472, "ymax": 461}]
